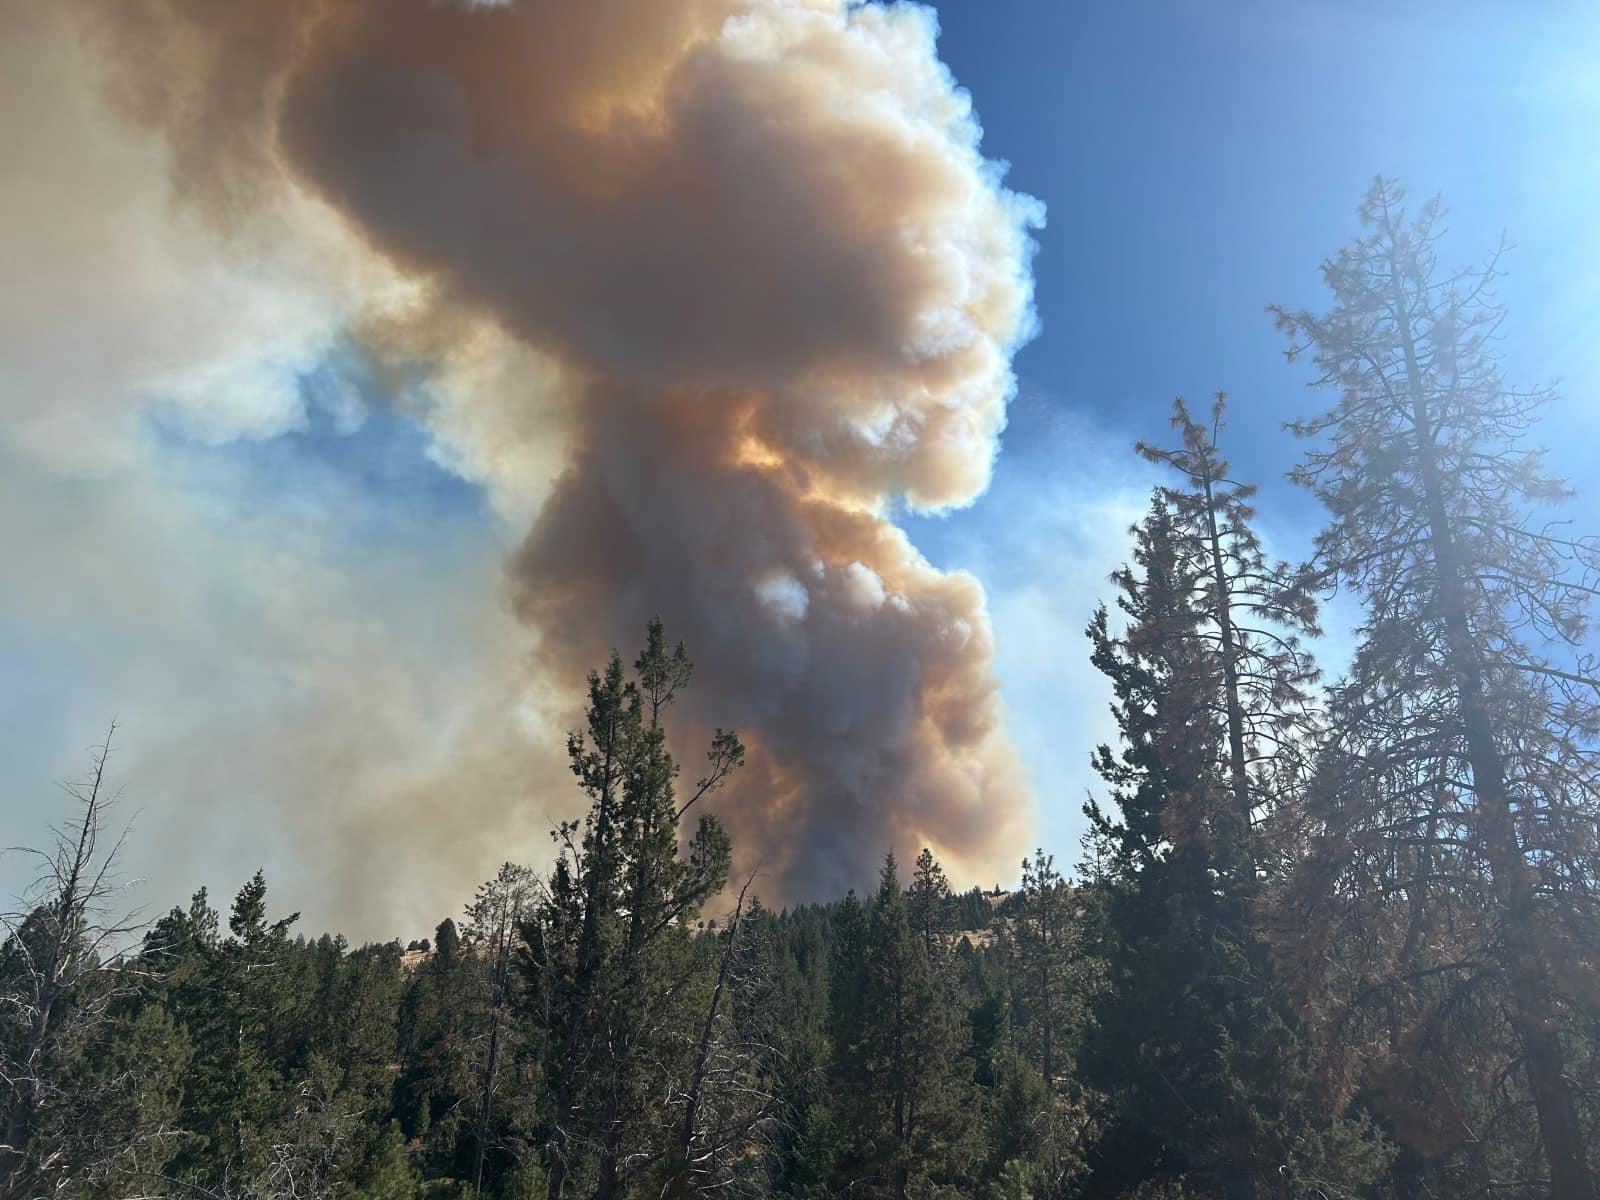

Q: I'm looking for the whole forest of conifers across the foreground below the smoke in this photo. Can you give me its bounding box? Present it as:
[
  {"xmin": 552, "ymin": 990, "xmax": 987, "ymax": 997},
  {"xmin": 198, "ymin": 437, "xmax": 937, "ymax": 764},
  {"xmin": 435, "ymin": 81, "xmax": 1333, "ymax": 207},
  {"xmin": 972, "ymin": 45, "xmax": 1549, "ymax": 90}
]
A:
[{"xmin": 9, "ymin": 181, "xmax": 1600, "ymax": 1200}]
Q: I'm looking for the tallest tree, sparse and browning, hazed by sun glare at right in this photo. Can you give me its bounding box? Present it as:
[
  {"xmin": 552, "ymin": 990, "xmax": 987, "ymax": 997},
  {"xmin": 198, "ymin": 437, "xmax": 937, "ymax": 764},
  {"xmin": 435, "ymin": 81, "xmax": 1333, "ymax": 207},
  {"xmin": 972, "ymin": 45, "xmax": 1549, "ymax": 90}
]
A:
[{"xmin": 1275, "ymin": 179, "xmax": 1600, "ymax": 1200}]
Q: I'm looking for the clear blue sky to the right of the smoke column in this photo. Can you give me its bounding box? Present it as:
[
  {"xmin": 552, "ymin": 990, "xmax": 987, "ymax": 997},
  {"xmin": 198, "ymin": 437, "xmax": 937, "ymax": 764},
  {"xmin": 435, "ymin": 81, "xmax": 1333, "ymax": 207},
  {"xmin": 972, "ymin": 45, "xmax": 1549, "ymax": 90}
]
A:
[{"xmin": 907, "ymin": 0, "xmax": 1600, "ymax": 858}]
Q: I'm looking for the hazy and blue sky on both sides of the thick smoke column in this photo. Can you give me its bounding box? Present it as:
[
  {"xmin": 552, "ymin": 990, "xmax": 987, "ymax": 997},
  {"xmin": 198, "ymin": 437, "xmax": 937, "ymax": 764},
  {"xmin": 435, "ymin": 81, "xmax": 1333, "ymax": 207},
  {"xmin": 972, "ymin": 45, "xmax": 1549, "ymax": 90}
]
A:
[{"xmin": 0, "ymin": 0, "xmax": 1600, "ymax": 936}]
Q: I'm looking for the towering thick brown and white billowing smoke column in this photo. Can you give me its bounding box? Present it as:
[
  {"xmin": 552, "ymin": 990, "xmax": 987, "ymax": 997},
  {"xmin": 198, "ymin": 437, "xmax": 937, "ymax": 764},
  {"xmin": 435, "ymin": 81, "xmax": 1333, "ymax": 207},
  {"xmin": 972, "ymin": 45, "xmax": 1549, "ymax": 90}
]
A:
[{"xmin": 62, "ymin": 0, "xmax": 1042, "ymax": 899}]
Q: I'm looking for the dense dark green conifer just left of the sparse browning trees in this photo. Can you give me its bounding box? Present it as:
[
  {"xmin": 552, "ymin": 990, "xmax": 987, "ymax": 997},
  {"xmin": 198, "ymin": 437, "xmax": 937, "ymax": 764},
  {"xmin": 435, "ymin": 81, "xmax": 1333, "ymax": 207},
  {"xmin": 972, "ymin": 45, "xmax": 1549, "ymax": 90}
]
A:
[{"xmin": 1083, "ymin": 493, "xmax": 1373, "ymax": 1200}]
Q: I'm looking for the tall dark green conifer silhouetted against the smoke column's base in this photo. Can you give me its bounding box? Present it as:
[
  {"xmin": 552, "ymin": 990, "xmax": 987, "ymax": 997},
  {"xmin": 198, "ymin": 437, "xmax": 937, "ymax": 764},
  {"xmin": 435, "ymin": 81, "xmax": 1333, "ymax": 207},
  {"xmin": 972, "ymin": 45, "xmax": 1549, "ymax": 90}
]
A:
[{"xmin": 525, "ymin": 621, "xmax": 744, "ymax": 1200}]
